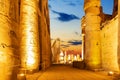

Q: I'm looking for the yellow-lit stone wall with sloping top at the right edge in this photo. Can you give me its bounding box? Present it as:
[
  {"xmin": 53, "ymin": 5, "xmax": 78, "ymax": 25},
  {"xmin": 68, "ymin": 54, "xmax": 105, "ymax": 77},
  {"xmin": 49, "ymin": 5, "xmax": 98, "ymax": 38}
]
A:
[{"xmin": 101, "ymin": 16, "xmax": 119, "ymax": 71}]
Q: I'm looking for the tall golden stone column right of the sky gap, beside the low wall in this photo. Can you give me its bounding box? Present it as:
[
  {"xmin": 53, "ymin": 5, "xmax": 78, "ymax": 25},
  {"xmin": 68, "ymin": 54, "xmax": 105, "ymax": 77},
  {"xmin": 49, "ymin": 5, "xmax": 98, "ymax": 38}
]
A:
[{"xmin": 84, "ymin": 0, "xmax": 101, "ymax": 69}]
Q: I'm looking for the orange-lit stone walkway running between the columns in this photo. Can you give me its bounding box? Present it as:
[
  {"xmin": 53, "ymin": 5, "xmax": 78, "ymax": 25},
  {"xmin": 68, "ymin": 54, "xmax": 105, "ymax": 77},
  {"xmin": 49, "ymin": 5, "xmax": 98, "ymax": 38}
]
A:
[{"xmin": 27, "ymin": 65, "xmax": 113, "ymax": 80}]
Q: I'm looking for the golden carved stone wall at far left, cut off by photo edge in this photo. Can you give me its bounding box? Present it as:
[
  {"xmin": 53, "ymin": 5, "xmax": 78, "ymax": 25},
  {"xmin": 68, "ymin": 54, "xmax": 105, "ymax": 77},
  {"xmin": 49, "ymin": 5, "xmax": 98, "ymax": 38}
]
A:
[{"xmin": 0, "ymin": 0, "xmax": 20, "ymax": 80}]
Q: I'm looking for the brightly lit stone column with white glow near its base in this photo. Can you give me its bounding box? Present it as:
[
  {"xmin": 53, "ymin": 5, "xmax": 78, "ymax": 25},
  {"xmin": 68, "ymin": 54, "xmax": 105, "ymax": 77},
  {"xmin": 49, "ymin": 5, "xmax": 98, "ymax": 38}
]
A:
[{"xmin": 20, "ymin": 0, "xmax": 40, "ymax": 72}]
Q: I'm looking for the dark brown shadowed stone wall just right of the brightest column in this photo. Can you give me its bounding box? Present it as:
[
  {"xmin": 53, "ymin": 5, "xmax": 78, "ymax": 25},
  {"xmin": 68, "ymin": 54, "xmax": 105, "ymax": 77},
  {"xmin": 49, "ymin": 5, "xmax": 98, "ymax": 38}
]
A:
[{"xmin": 39, "ymin": 0, "xmax": 52, "ymax": 70}]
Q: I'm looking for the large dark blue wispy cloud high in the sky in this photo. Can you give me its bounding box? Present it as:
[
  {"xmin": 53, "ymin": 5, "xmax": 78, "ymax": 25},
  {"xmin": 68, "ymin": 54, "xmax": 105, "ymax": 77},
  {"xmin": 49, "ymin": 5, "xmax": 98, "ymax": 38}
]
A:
[{"xmin": 52, "ymin": 10, "xmax": 80, "ymax": 22}]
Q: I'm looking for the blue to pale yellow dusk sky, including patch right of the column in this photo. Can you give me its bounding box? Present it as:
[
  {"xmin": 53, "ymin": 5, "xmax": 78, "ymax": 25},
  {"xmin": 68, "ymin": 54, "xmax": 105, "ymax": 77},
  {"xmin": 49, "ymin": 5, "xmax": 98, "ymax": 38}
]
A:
[{"xmin": 49, "ymin": 0, "xmax": 113, "ymax": 50}]
